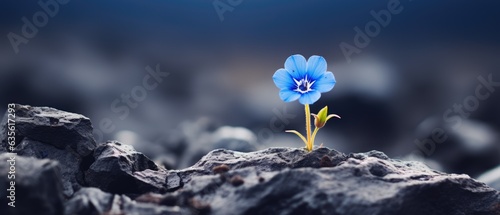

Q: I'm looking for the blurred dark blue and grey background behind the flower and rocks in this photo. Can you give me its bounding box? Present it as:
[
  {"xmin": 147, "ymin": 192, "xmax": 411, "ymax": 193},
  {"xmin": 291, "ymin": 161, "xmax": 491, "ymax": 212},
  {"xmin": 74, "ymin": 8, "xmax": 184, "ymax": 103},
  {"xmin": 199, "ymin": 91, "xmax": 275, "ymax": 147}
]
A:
[{"xmin": 0, "ymin": 0, "xmax": 500, "ymax": 177}]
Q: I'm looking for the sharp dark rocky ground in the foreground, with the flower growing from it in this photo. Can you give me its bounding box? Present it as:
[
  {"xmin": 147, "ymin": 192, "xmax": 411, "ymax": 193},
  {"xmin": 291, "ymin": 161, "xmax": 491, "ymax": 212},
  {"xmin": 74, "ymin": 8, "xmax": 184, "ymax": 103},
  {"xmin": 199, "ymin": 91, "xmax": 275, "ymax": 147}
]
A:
[{"xmin": 0, "ymin": 105, "xmax": 500, "ymax": 215}]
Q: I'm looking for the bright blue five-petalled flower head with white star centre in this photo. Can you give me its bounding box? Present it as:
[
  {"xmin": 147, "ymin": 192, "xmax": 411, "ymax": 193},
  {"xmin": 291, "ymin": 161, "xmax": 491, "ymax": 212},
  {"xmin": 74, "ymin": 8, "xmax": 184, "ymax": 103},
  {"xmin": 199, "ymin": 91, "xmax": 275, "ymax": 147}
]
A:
[{"xmin": 273, "ymin": 54, "xmax": 336, "ymax": 105}]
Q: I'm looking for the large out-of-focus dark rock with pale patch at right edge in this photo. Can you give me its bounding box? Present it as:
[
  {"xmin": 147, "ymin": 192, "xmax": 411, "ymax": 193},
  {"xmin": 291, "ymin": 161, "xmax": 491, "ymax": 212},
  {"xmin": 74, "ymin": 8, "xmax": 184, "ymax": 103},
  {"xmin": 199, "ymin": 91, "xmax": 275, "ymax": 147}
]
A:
[{"xmin": 415, "ymin": 116, "xmax": 500, "ymax": 177}]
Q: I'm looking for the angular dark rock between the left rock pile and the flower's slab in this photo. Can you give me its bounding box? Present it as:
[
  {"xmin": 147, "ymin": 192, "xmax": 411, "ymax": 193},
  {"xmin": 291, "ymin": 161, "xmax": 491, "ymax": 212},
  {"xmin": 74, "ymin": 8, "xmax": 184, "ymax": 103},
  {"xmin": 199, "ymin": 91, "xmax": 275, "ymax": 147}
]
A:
[{"xmin": 83, "ymin": 141, "xmax": 167, "ymax": 194}]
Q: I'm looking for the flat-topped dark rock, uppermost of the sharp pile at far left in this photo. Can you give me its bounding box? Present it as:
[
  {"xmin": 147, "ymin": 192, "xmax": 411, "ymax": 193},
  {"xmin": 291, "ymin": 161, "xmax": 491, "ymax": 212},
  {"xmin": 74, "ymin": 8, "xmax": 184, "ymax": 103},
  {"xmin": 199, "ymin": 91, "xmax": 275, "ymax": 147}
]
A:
[{"xmin": 2, "ymin": 104, "xmax": 96, "ymax": 156}]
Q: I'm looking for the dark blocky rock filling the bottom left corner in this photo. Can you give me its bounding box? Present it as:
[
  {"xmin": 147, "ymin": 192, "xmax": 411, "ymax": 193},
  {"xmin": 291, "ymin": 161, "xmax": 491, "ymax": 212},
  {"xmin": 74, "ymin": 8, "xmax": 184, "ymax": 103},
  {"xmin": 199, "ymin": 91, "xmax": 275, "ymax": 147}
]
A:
[{"xmin": 0, "ymin": 153, "xmax": 64, "ymax": 215}]
